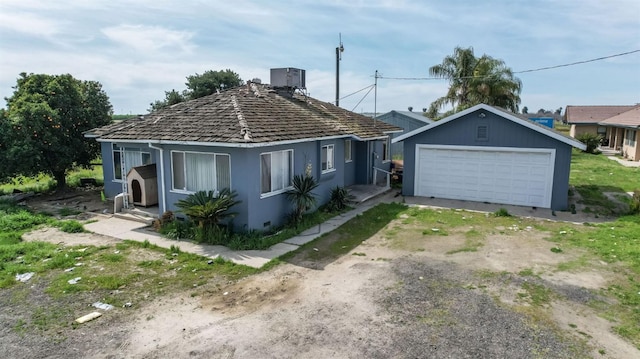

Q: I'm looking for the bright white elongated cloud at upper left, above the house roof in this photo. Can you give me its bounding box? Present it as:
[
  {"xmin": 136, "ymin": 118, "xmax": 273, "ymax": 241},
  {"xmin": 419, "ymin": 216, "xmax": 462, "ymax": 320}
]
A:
[{"xmin": 101, "ymin": 24, "xmax": 195, "ymax": 53}]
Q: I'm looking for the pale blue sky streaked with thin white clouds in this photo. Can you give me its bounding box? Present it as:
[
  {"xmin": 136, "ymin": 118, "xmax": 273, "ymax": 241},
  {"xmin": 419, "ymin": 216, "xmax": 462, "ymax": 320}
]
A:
[{"xmin": 0, "ymin": 0, "xmax": 640, "ymax": 114}]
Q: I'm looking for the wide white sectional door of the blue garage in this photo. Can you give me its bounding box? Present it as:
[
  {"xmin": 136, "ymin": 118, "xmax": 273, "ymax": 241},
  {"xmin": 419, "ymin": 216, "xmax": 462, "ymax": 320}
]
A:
[{"xmin": 414, "ymin": 145, "xmax": 555, "ymax": 208}]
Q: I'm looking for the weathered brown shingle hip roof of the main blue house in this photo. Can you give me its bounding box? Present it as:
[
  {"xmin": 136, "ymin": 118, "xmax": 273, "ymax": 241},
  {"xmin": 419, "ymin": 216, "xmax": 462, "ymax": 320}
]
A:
[{"xmin": 85, "ymin": 83, "xmax": 402, "ymax": 147}]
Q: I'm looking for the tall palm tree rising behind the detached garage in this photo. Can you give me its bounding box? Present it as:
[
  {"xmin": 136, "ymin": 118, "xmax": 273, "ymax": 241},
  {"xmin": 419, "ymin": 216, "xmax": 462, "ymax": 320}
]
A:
[{"xmin": 428, "ymin": 47, "xmax": 522, "ymax": 118}]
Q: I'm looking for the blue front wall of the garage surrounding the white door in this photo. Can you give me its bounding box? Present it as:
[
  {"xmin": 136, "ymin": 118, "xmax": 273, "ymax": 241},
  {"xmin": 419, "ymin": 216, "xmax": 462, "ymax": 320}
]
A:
[{"xmin": 402, "ymin": 110, "xmax": 572, "ymax": 210}]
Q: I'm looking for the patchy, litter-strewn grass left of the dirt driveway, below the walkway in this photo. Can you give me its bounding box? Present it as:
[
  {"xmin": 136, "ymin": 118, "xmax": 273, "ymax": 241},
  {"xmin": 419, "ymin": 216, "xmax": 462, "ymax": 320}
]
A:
[{"xmin": 0, "ymin": 200, "xmax": 258, "ymax": 340}]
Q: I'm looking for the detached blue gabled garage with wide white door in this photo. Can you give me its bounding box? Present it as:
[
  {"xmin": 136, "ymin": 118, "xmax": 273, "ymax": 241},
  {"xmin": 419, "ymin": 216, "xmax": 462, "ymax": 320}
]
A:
[{"xmin": 393, "ymin": 104, "xmax": 585, "ymax": 210}]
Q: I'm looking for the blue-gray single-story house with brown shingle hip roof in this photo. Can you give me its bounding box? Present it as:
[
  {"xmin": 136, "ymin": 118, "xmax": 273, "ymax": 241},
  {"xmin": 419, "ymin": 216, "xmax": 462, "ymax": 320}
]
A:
[{"xmin": 85, "ymin": 83, "xmax": 401, "ymax": 230}]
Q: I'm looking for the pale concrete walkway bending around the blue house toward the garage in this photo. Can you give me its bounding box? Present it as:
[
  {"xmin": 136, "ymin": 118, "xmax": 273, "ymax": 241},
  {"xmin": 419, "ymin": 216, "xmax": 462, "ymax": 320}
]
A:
[{"xmin": 84, "ymin": 191, "xmax": 402, "ymax": 268}]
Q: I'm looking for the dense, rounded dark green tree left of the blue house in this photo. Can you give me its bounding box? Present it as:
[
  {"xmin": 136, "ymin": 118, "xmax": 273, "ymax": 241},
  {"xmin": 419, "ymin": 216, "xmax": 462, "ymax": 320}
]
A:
[{"xmin": 0, "ymin": 73, "xmax": 113, "ymax": 188}]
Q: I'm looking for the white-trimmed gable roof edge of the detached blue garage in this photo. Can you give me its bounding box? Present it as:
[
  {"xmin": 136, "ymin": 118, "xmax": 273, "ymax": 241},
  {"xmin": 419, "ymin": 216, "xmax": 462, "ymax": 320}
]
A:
[{"xmin": 392, "ymin": 104, "xmax": 587, "ymax": 150}]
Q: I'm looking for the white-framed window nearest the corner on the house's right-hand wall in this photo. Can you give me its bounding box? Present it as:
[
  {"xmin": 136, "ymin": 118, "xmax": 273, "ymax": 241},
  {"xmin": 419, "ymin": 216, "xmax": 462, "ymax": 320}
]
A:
[{"xmin": 260, "ymin": 150, "xmax": 293, "ymax": 196}]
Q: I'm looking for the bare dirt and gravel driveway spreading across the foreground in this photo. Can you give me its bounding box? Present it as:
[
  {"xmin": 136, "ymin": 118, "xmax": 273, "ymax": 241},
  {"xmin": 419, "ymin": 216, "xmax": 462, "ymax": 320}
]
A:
[{"xmin": 8, "ymin": 207, "xmax": 640, "ymax": 358}]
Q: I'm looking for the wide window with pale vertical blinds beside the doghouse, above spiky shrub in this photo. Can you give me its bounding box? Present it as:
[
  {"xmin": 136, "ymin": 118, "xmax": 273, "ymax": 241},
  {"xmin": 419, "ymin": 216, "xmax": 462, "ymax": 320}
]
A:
[{"xmin": 171, "ymin": 151, "xmax": 231, "ymax": 192}]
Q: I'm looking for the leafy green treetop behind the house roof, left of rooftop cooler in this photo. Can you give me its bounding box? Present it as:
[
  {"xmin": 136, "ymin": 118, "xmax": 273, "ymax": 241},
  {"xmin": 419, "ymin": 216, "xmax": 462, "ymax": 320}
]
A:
[{"xmin": 149, "ymin": 69, "xmax": 243, "ymax": 111}]
